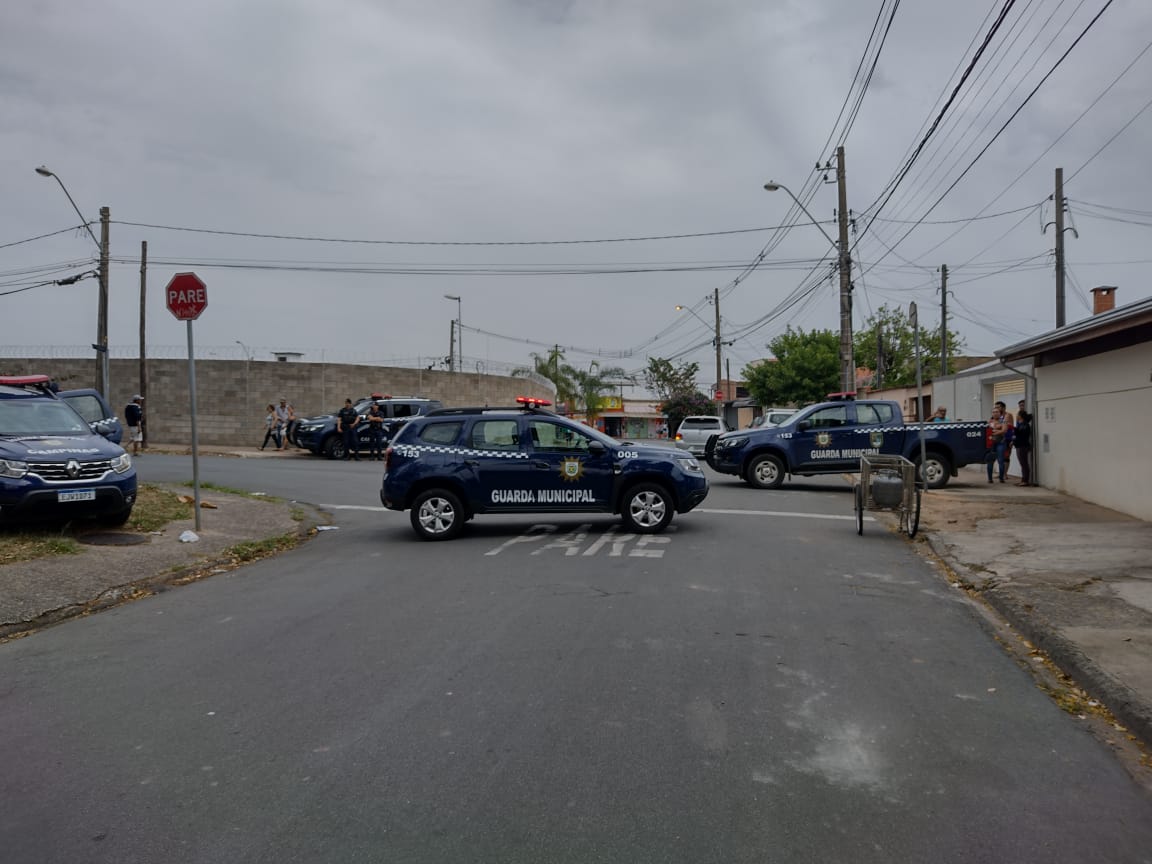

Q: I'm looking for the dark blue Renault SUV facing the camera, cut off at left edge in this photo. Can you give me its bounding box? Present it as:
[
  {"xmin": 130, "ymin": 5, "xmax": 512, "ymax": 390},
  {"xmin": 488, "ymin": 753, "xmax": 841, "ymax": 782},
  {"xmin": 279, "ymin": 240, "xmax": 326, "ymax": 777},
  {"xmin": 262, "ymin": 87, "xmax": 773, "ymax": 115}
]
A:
[{"xmin": 0, "ymin": 376, "xmax": 136, "ymax": 525}]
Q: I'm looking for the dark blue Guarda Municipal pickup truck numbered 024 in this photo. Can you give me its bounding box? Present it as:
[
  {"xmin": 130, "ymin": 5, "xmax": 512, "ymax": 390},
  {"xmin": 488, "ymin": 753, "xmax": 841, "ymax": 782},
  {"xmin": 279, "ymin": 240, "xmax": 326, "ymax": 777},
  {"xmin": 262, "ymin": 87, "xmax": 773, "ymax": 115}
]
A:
[{"xmin": 704, "ymin": 400, "xmax": 986, "ymax": 488}]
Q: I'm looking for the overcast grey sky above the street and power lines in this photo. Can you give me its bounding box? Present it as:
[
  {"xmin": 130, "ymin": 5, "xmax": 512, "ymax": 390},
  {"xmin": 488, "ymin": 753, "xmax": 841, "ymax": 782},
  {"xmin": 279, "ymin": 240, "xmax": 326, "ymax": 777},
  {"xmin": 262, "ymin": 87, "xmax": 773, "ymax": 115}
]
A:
[{"xmin": 0, "ymin": 0, "xmax": 1152, "ymax": 385}]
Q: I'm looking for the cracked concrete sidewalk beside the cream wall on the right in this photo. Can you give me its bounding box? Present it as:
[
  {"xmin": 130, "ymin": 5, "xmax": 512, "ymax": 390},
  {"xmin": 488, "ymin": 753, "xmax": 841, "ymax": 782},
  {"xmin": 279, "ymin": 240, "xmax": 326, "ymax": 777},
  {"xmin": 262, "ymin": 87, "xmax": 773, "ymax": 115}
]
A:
[{"xmin": 920, "ymin": 465, "xmax": 1152, "ymax": 745}]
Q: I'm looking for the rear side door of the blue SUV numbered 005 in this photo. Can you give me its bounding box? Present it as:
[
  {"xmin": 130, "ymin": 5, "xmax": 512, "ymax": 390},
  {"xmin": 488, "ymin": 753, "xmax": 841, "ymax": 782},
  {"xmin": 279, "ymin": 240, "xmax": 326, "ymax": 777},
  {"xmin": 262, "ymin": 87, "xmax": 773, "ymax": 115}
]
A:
[{"xmin": 464, "ymin": 417, "xmax": 536, "ymax": 511}]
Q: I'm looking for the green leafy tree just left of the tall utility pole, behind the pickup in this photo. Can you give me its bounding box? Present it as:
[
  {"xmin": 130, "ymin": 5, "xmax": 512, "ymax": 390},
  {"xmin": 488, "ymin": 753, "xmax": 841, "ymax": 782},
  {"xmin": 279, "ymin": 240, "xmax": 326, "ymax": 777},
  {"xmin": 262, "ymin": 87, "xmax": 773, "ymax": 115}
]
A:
[{"xmin": 743, "ymin": 327, "xmax": 841, "ymax": 408}]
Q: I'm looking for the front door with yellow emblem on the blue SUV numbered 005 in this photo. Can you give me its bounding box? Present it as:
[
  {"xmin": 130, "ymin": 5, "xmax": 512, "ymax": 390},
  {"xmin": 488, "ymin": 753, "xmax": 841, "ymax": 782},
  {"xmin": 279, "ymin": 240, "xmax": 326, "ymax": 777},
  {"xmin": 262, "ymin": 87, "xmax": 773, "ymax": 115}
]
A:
[{"xmin": 526, "ymin": 417, "xmax": 615, "ymax": 511}]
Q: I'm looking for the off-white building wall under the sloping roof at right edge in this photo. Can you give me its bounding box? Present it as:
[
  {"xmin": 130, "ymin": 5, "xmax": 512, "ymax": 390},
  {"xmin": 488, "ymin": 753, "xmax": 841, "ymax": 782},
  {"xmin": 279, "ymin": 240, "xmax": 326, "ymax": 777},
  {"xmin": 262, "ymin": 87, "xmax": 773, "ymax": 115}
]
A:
[{"xmin": 1036, "ymin": 343, "xmax": 1152, "ymax": 520}]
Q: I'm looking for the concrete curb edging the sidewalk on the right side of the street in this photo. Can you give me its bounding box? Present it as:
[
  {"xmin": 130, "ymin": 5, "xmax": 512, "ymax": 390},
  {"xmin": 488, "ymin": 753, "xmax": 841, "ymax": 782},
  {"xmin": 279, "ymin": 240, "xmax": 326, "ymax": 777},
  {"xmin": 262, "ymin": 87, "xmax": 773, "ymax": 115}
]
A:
[{"xmin": 924, "ymin": 532, "xmax": 1152, "ymax": 746}]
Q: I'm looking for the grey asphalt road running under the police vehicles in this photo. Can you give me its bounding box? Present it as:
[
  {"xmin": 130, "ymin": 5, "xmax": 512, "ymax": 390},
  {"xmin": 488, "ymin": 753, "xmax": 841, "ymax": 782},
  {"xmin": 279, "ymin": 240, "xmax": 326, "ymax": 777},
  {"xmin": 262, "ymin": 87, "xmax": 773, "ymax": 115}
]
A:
[{"xmin": 0, "ymin": 456, "xmax": 1152, "ymax": 864}]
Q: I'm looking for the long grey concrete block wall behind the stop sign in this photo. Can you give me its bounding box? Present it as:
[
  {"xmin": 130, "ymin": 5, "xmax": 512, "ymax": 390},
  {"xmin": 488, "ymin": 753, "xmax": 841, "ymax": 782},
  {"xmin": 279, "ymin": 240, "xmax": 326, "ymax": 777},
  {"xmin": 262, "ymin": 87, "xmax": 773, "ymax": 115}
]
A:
[{"xmin": 0, "ymin": 358, "xmax": 555, "ymax": 447}]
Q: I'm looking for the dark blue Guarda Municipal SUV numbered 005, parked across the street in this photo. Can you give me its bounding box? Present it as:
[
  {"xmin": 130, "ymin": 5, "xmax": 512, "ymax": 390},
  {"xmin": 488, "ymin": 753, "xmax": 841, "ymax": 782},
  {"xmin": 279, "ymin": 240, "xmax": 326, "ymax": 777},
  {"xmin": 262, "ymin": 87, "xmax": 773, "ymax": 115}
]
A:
[{"xmin": 380, "ymin": 397, "xmax": 708, "ymax": 540}]
